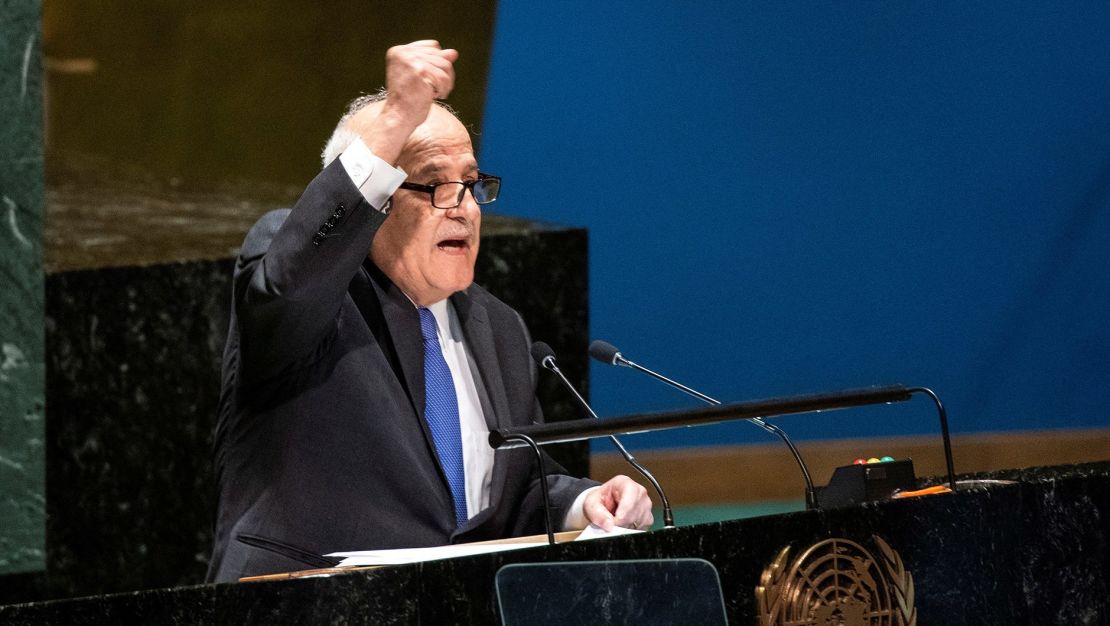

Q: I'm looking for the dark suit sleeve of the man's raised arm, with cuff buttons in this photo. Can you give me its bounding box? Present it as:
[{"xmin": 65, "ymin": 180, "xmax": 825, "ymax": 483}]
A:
[{"xmin": 233, "ymin": 160, "xmax": 392, "ymax": 382}]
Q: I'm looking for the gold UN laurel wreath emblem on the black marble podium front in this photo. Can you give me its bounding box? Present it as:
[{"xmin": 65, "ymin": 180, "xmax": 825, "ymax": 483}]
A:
[{"xmin": 756, "ymin": 535, "xmax": 917, "ymax": 626}]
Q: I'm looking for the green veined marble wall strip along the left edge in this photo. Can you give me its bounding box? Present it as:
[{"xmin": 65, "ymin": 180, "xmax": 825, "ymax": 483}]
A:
[{"xmin": 0, "ymin": 0, "xmax": 46, "ymax": 574}]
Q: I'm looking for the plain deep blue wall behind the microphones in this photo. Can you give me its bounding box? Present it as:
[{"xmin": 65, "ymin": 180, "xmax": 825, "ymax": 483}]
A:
[{"xmin": 481, "ymin": 1, "xmax": 1110, "ymax": 446}]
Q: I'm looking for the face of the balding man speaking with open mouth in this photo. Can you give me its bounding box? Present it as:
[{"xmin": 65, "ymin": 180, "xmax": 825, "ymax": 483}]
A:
[{"xmin": 370, "ymin": 107, "xmax": 482, "ymax": 306}]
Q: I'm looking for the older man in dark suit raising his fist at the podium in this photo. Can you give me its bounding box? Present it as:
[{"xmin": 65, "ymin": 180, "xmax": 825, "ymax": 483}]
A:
[{"xmin": 209, "ymin": 41, "xmax": 653, "ymax": 580}]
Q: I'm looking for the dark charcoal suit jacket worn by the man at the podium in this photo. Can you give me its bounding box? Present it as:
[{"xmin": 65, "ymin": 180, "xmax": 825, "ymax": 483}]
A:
[{"xmin": 209, "ymin": 161, "xmax": 596, "ymax": 580}]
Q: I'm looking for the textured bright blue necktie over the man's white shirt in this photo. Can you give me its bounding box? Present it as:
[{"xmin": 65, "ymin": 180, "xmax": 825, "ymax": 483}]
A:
[{"xmin": 418, "ymin": 306, "xmax": 467, "ymax": 526}]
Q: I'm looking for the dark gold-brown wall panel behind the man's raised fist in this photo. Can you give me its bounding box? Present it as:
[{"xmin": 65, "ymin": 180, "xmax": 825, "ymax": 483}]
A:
[{"xmin": 43, "ymin": 0, "xmax": 495, "ymax": 189}]
